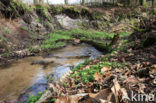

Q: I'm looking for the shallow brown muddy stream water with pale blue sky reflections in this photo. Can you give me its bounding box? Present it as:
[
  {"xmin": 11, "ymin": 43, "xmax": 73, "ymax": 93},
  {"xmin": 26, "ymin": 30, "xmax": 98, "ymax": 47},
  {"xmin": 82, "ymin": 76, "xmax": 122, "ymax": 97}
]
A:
[{"xmin": 0, "ymin": 44, "xmax": 101, "ymax": 103}]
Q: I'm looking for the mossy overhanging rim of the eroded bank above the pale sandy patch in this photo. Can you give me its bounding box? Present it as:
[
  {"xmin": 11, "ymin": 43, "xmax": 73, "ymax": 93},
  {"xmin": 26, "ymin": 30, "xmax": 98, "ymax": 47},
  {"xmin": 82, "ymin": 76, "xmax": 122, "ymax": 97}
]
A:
[{"xmin": 49, "ymin": 5, "xmax": 105, "ymax": 20}]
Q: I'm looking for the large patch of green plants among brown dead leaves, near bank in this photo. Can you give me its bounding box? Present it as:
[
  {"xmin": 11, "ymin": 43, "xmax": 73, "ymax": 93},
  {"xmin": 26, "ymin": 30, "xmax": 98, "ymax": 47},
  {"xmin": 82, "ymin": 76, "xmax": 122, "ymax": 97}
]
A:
[{"xmin": 71, "ymin": 55, "xmax": 126, "ymax": 84}]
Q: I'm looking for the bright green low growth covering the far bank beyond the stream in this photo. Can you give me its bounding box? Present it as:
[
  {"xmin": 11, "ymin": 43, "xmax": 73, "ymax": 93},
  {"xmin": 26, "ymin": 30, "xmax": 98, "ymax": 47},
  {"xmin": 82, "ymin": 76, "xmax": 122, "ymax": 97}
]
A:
[{"xmin": 42, "ymin": 29, "xmax": 131, "ymax": 52}]
